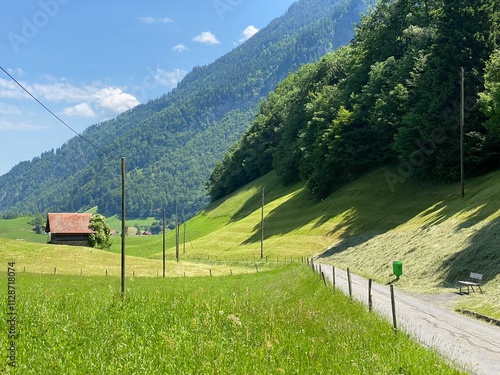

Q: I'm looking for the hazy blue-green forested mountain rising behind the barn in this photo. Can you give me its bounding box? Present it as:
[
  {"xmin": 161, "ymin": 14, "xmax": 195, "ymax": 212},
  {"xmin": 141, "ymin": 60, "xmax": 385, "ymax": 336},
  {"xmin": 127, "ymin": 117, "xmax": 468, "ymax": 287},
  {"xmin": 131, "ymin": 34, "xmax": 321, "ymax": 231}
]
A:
[{"xmin": 0, "ymin": 0, "xmax": 374, "ymax": 217}]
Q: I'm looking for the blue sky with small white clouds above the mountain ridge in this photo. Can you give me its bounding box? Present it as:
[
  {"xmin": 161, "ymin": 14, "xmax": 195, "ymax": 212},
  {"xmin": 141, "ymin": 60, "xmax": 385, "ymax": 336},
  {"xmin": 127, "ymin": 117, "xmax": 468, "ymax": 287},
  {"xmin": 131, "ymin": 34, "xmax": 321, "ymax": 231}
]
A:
[{"xmin": 0, "ymin": 0, "xmax": 296, "ymax": 175}]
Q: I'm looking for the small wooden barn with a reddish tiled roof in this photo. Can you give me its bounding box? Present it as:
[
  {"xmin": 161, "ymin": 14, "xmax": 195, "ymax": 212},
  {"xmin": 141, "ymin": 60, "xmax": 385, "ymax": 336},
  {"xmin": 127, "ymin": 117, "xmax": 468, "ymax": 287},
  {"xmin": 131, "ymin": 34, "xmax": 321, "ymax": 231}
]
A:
[{"xmin": 45, "ymin": 213, "xmax": 94, "ymax": 246}]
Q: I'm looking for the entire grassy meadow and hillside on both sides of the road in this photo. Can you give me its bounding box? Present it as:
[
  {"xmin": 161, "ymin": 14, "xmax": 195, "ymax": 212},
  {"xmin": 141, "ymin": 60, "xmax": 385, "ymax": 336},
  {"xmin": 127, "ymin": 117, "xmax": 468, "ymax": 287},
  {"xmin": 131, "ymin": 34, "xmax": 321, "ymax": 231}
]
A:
[{"xmin": 0, "ymin": 169, "xmax": 500, "ymax": 374}]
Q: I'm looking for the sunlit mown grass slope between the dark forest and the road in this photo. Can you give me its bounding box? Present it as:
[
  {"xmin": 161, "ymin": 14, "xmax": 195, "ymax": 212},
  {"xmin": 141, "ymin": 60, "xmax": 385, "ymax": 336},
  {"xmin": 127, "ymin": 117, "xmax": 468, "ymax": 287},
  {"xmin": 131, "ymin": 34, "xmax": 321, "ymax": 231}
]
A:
[{"xmin": 185, "ymin": 167, "xmax": 500, "ymax": 318}]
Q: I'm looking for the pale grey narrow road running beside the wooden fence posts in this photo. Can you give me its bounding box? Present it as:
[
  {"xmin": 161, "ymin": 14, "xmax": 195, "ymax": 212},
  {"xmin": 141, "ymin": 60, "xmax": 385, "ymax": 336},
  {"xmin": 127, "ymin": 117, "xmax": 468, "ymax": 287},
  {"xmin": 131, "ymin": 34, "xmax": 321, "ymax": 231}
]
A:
[{"xmin": 315, "ymin": 264, "xmax": 500, "ymax": 375}]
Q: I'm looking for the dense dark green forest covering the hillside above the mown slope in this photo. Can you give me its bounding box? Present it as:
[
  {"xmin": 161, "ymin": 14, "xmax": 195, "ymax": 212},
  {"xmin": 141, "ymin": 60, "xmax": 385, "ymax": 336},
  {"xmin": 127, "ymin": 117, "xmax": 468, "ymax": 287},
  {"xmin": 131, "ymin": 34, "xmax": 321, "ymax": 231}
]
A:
[{"xmin": 207, "ymin": 0, "xmax": 500, "ymax": 200}]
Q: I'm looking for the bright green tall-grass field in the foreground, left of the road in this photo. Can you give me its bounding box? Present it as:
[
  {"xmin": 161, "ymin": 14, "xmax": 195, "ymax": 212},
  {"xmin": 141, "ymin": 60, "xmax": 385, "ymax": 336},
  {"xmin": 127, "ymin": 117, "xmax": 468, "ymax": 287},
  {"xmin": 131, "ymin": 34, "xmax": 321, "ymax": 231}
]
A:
[{"xmin": 0, "ymin": 264, "xmax": 461, "ymax": 374}]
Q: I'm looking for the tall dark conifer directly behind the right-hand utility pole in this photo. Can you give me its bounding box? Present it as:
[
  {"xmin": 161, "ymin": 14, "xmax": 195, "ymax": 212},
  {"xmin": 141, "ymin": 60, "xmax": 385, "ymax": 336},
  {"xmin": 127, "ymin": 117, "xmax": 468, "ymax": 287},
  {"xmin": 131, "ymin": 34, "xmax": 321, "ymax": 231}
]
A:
[{"xmin": 395, "ymin": 0, "xmax": 498, "ymax": 180}]
